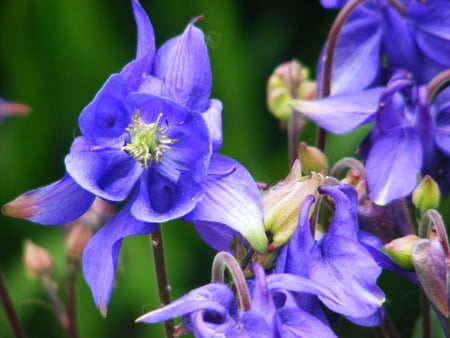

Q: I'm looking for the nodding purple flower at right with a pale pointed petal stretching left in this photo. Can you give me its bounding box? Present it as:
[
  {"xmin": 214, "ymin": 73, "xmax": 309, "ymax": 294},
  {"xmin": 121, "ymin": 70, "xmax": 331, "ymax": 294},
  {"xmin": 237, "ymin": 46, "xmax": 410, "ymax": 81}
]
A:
[{"xmin": 295, "ymin": 71, "xmax": 450, "ymax": 205}]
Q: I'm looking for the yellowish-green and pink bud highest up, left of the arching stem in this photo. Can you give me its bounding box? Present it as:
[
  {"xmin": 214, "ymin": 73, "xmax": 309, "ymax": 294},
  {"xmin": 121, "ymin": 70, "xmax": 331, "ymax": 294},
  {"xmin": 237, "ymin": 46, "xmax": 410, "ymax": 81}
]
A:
[{"xmin": 267, "ymin": 60, "xmax": 317, "ymax": 121}]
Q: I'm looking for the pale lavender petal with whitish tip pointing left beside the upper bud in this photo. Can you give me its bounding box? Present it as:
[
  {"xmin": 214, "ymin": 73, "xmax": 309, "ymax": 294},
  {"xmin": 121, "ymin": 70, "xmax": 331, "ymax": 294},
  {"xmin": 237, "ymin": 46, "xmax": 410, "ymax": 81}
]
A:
[{"xmin": 293, "ymin": 87, "xmax": 384, "ymax": 134}]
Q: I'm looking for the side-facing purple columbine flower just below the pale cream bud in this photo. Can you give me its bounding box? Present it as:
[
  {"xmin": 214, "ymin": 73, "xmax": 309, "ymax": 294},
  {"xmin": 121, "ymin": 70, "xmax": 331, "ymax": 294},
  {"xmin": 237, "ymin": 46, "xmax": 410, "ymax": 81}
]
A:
[{"xmin": 275, "ymin": 185, "xmax": 384, "ymax": 326}]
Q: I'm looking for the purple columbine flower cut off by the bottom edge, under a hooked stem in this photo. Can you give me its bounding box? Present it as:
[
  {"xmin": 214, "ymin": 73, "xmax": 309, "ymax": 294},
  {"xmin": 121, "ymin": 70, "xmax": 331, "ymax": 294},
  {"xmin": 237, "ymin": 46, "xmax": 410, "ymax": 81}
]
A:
[{"xmin": 137, "ymin": 264, "xmax": 336, "ymax": 338}]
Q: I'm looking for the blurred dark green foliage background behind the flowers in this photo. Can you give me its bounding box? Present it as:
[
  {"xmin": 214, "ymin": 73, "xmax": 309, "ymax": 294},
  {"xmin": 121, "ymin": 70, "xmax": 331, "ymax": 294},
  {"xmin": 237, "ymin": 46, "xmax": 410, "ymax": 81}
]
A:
[{"xmin": 0, "ymin": 0, "xmax": 417, "ymax": 338}]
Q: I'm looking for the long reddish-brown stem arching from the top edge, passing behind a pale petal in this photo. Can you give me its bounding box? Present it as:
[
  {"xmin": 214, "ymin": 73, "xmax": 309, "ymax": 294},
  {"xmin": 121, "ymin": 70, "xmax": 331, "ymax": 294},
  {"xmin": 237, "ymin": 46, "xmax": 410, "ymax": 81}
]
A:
[{"xmin": 316, "ymin": 0, "xmax": 365, "ymax": 151}]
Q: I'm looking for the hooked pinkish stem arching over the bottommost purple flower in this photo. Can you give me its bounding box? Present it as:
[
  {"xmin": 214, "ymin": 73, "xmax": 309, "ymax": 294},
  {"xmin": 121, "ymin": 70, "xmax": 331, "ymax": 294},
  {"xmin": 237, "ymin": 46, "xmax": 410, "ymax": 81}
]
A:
[{"xmin": 212, "ymin": 251, "xmax": 251, "ymax": 312}]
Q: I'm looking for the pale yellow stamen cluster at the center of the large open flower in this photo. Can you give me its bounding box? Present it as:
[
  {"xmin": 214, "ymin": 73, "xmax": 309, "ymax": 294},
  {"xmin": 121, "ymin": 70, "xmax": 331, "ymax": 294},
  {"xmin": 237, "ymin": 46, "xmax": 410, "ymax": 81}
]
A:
[{"xmin": 122, "ymin": 110, "xmax": 178, "ymax": 169}]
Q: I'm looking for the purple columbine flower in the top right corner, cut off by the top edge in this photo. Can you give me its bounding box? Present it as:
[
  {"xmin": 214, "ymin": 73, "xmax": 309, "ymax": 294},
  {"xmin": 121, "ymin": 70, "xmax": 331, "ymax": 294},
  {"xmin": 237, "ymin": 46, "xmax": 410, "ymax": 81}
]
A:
[{"xmin": 318, "ymin": 0, "xmax": 450, "ymax": 94}]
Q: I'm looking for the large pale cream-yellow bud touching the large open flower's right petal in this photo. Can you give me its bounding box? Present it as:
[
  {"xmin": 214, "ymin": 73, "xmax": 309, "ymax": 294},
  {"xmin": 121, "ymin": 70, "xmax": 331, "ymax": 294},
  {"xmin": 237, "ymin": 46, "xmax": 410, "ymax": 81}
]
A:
[{"xmin": 263, "ymin": 160, "xmax": 323, "ymax": 249}]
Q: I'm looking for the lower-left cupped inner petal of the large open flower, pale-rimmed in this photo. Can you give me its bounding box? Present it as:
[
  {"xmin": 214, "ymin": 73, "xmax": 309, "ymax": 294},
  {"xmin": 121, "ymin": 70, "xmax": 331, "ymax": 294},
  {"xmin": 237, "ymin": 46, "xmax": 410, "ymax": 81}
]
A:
[{"xmin": 65, "ymin": 137, "xmax": 143, "ymax": 201}]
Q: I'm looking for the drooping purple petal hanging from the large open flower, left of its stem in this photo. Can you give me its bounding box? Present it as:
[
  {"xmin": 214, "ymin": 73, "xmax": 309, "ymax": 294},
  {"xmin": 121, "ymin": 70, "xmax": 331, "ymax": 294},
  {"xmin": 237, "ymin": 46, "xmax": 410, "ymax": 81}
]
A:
[{"xmin": 83, "ymin": 204, "xmax": 157, "ymax": 316}]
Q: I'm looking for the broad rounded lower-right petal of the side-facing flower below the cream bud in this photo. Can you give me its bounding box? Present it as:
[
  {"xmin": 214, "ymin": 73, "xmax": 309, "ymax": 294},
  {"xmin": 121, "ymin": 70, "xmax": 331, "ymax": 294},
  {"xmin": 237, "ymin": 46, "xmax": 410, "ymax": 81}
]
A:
[{"xmin": 309, "ymin": 235, "xmax": 385, "ymax": 317}]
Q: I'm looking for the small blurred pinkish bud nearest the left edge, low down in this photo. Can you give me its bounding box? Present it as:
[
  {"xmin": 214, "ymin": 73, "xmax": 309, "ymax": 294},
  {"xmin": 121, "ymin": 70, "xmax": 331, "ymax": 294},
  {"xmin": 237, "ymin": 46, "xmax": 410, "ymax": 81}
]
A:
[{"xmin": 23, "ymin": 239, "xmax": 53, "ymax": 279}]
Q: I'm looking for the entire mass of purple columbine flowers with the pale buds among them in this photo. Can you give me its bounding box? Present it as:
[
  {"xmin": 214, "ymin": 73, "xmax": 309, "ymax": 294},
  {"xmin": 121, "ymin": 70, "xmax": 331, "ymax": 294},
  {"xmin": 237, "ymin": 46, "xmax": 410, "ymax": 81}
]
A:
[{"xmin": 2, "ymin": 0, "xmax": 450, "ymax": 337}]
